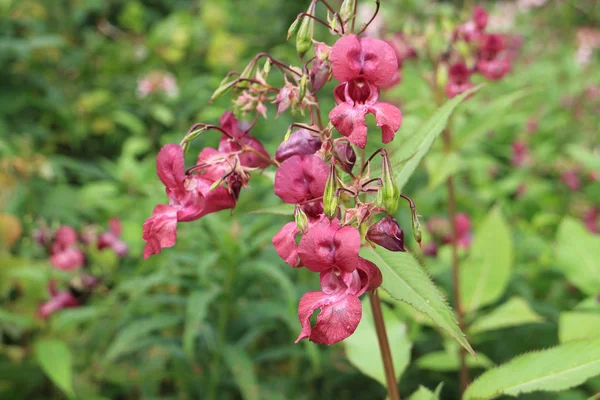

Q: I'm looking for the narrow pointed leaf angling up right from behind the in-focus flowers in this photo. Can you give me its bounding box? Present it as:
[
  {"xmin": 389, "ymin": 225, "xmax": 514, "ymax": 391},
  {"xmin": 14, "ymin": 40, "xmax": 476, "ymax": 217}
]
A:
[{"xmin": 391, "ymin": 86, "xmax": 481, "ymax": 190}]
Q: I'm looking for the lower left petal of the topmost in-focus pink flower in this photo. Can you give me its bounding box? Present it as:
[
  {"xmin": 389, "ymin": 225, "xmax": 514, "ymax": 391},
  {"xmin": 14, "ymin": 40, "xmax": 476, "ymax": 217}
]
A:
[{"xmin": 329, "ymin": 103, "xmax": 368, "ymax": 149}]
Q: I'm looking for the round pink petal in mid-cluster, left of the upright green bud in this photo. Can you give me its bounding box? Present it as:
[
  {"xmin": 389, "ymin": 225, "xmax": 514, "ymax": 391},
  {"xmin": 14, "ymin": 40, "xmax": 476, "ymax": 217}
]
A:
[{"xmin": 274, "ymin": 154, "xmax": 329, "ymax": 204}]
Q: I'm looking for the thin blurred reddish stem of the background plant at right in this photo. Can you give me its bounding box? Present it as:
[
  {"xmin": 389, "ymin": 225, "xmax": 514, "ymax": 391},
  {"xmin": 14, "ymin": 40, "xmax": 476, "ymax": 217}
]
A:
[{"xmin": 442, "ymin": 128, "xmax": 469, "ymax": 393}]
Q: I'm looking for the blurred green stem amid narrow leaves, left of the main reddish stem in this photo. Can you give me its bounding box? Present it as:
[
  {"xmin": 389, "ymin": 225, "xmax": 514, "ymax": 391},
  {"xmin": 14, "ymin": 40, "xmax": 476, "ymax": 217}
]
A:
[{"xmin": 207, "ymin": 260, "xmax": 236, "ymax": 400}]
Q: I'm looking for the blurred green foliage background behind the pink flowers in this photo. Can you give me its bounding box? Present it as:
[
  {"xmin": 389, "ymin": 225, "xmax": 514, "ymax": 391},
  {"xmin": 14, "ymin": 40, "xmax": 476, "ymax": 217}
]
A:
[{"xmin": 0, "ymin": 0, "xmax": 600, "ymax": 400}]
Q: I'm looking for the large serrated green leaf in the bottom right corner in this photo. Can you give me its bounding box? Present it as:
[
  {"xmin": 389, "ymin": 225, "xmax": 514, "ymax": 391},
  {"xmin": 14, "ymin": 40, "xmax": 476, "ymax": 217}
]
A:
[{"xmin": 464, "ymin": 338, "xmax": 600, "ymax": 400}]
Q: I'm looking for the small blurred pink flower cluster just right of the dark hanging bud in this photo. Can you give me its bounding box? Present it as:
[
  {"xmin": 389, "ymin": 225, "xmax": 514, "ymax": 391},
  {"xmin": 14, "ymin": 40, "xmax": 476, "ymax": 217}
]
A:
[{"xmin": 423, "ymin": 213, "xmax": 473, "ymax": 257}]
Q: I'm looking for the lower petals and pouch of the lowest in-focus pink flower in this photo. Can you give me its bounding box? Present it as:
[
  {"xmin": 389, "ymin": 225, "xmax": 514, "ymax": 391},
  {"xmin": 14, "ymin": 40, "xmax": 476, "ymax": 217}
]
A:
[{"xmin": 296, "ymin": 258, "xmax": 381, "ymax": 345}]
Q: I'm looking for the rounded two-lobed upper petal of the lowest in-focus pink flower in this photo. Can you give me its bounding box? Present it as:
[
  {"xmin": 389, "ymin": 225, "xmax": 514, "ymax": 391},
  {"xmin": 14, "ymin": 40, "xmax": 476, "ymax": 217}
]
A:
[{"xmin": 298, "ymin": 220, "xmax": 360, "ymax": 272}]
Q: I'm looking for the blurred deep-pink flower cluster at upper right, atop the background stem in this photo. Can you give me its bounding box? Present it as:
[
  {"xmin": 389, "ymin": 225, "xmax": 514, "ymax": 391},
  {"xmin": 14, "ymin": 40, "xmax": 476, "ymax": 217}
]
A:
[{"xmin": 443, "ymin": 7, "xmax": 519, "ymax": 98}]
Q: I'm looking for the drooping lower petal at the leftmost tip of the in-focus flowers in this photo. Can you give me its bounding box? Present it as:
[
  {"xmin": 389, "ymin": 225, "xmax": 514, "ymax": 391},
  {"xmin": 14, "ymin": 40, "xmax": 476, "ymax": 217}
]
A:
[{"xmin": 142, "ymin": 204, "xmax": 177, "ymax": 259}]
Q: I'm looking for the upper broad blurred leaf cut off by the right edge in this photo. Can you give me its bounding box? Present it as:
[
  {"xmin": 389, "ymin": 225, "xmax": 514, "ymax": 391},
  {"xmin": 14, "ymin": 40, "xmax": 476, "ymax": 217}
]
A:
[{"xmin": 556, "ymin": 217, "xmax": 600, "ymax": 296}]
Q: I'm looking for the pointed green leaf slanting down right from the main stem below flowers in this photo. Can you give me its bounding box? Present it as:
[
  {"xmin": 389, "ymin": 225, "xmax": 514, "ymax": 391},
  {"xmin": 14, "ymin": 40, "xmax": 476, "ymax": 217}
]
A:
[{"xmin": 362, "ymin": 247, "xmax": 475, "ymax": 355}]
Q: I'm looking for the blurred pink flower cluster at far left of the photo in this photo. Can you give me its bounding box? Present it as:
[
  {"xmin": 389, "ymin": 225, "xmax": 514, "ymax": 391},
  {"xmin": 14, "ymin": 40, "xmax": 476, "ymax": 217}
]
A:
[{"xmin": 34, "ymin": 218, "xmax": 129, "ymax": 319}]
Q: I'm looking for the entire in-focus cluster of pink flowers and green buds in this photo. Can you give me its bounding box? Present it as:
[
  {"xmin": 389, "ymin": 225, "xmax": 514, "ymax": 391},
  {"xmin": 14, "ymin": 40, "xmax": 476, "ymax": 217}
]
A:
[{"xmin": 143, "ymin": 0, "xmax": 428, "ymax": 344}]
